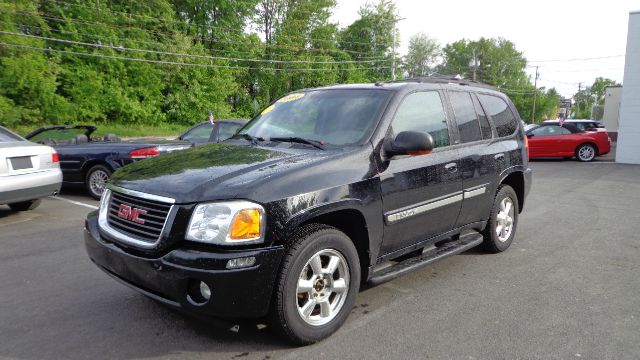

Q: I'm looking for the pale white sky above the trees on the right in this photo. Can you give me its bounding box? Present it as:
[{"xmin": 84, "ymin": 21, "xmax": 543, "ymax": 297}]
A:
[{"xmin": 333, "ymin": 0, "xmax": 640, "ymax": 97}]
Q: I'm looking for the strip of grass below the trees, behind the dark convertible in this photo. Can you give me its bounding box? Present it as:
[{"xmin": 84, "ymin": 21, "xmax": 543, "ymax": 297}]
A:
[{"xmin": 12, "ymin": 124, "xmax": 185, "ymax": 138}]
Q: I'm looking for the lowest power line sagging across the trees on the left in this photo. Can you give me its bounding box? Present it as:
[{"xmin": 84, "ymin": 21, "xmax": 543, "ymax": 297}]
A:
[{"xmin": 0, "ymin": 42, "xmax": 391, "ymax": 71}]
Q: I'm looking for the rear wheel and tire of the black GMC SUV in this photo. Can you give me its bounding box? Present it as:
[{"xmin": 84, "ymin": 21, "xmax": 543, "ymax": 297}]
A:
[{"xmin": 482, "ymin": 185, "xmax": 519, "ymax": 254}]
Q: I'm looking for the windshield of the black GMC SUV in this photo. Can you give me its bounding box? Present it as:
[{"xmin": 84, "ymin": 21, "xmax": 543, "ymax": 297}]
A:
[{"xmin": 239, "ymin": 89, "xmax": 391, "ymax": 145}]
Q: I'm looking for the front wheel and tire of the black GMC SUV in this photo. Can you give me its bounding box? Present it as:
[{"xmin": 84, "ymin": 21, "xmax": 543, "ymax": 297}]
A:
[{"xmin": 269, "ymin": 224, "xmax": 360, "ymax": 345}]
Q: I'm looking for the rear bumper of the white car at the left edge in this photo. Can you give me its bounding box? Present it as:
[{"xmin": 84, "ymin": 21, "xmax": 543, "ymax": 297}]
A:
[{"xmin": 0, "ymin": 169, "xmax": 62, "ymax": 204}]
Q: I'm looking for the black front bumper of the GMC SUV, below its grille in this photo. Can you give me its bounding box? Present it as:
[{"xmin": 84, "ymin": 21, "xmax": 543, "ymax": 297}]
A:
[{"xmin": 84, "ymin": 212, "xmax": 284, "ymax": 318}]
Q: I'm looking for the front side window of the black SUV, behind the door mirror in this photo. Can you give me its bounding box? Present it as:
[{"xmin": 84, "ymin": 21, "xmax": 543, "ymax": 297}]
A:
[{"xmin": 392, "ymin": 91, "xmax": 449, "ymax": 148}]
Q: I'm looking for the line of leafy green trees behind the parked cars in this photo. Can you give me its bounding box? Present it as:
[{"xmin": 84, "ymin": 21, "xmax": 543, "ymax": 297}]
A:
[{"xmin": 0, "ymin": 0, "xmax": 560, "ymax": 127}]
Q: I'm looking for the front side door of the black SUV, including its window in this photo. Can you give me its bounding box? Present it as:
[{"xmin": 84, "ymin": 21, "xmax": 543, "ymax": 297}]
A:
[{"xmin": 380, "ymin": 91, "xmax": 462, "ymax": 255}]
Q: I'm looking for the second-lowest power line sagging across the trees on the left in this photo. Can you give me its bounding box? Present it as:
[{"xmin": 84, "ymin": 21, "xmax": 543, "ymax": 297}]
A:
[{"xmin": 0, "ymin": 31, "xmax": 390, "ymax": 65}]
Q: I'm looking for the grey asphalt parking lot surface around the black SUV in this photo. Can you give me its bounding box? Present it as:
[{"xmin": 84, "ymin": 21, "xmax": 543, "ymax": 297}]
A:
[{"xmin": 0, "ymin": 159, "xmax": 640, "ymax": 360}]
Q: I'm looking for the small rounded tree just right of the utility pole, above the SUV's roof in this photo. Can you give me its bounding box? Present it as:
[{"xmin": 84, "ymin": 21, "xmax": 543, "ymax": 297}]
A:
[{"xmin": 404, "ymin": 33, "xmax": 440, "ymax": 77}]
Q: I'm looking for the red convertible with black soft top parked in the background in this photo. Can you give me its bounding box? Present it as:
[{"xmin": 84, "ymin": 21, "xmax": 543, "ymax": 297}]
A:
[{"xmin": 527, "ymin": 122, "xmax": 611, "ymax": 161}]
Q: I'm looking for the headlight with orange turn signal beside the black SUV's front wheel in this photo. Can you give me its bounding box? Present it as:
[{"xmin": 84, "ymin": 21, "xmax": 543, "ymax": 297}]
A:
[{"xmin": 186, "ymin": 201, "xmax": 265, "ymax": 245}]
